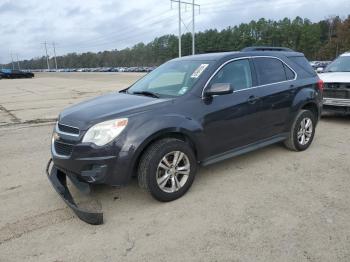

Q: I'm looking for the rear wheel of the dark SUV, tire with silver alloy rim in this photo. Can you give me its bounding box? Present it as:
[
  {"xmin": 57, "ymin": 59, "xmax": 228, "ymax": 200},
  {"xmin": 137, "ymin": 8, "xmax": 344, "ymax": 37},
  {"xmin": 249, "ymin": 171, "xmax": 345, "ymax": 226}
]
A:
[{"xmin": 284, "ymin": 110, "xmax": 316, "ymax": 151}]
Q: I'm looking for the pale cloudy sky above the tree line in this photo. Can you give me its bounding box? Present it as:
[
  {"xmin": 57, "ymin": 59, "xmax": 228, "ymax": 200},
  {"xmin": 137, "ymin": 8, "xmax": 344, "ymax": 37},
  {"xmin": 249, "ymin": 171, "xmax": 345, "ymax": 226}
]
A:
[{"xmin": 0, "ymin": 0, "xmax": 350, "ymax": 64}]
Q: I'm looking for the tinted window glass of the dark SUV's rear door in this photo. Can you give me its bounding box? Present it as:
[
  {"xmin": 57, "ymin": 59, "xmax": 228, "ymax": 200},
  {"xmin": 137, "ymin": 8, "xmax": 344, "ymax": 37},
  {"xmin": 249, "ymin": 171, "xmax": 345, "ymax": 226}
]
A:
[{"xmin": 253, "ymin": 57, "xmax": 287, "ymax": 85}]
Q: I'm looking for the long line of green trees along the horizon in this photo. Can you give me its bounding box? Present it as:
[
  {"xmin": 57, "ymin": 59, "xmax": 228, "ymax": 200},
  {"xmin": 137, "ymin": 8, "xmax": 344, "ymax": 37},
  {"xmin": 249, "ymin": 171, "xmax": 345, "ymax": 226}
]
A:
[{"xmin": 3, "ymin": 15, "xmax": 350, "ymax": 69}]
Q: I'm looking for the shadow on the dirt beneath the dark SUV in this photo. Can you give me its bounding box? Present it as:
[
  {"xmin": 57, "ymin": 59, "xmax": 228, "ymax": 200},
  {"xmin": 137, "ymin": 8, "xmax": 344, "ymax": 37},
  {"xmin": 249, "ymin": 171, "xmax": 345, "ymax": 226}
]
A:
[{"xmin": 72, "ymin": 144, "xmax": 288, "ymax": 215}]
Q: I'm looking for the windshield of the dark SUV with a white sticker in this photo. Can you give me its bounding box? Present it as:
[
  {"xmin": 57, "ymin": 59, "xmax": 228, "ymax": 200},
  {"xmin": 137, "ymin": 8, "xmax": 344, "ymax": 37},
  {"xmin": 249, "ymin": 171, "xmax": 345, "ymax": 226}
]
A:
[{"xmin": 127, "ymin": 60, "xmax": 210, "ymax": 97}]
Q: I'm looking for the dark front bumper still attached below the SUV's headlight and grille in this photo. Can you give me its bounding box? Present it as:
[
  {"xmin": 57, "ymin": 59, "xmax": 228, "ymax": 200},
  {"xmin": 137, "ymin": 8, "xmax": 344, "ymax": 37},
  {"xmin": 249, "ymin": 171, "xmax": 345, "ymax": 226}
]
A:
[{"xmin": 51, "ymin": 130, "xmax": 132, "ymax": 186}]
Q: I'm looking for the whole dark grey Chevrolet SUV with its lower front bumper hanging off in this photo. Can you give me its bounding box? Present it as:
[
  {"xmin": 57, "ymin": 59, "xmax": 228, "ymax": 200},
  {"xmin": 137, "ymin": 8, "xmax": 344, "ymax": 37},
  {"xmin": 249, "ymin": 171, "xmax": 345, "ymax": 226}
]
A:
[{"xmin": 47, "ymin": 47, "xmax": 323, "ymax": 224}]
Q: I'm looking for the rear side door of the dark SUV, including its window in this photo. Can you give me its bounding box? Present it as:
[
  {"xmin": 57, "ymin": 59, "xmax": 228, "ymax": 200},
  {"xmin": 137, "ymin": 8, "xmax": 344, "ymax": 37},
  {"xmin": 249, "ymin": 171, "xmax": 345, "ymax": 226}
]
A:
[{"xmin": 253, "ymin": 57, "xmax": 296, "ymax": 139}]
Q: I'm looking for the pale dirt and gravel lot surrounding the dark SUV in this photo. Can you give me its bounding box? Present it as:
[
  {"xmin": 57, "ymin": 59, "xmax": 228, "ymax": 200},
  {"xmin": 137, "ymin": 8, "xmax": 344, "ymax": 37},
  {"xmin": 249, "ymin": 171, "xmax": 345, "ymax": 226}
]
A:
[{"xmin": 0, "ymin": 73, "xmax": 350, "ymax": 262}]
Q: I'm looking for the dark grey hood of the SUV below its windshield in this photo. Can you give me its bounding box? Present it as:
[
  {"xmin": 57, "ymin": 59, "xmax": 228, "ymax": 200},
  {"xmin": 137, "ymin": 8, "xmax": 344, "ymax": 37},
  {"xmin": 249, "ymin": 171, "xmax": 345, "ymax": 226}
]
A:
[{"xmin": 59, "ymin": 92, "xmax": 170, "ymax": 130}]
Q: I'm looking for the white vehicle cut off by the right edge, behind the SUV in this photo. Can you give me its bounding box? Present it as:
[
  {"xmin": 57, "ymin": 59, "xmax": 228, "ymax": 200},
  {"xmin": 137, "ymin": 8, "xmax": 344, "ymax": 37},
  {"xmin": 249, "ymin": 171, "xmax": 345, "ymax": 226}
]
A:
[{"xmin": 319, "ymin": 52, "xmax": 350, "ymax": 113}]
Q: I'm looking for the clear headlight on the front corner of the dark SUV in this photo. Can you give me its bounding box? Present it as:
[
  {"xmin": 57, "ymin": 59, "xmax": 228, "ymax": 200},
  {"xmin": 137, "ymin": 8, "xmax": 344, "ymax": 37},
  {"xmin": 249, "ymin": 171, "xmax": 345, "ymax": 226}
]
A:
[{"xmin": 83, "ymin": 118, "xmax": 128, "ymax": 146}]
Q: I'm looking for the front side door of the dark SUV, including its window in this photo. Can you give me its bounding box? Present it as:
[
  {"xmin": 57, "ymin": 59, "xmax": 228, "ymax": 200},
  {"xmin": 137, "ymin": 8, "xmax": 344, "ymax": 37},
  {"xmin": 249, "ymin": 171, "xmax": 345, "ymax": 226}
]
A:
[{"xmin": 203, "ymin": 59, "xmax": 261, "ymax": 157}]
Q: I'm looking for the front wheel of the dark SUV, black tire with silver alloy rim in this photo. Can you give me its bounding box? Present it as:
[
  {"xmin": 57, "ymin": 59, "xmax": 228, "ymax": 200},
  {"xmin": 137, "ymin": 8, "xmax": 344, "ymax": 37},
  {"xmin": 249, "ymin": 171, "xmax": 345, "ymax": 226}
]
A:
[{"xmin": 138, "ymin": 138, "xmax": 197, "ymax": 202}]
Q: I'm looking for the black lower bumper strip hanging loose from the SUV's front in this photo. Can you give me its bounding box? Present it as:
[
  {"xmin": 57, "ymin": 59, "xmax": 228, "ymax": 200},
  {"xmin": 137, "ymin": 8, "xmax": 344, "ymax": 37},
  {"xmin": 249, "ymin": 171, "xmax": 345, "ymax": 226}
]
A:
[{"xmin": 46, "ymin": 159, "xmax": 103, "ymax": 225}]
